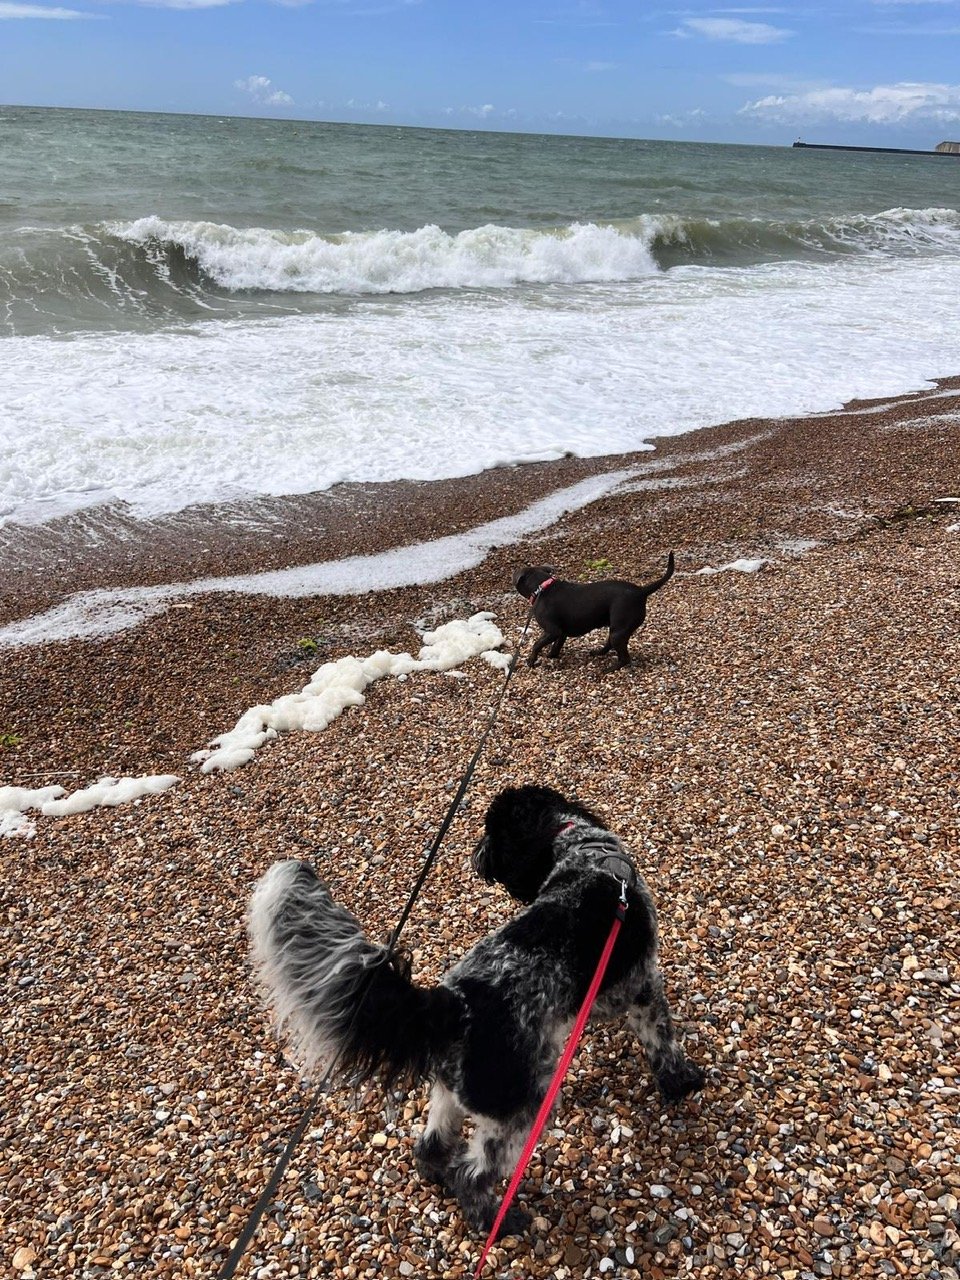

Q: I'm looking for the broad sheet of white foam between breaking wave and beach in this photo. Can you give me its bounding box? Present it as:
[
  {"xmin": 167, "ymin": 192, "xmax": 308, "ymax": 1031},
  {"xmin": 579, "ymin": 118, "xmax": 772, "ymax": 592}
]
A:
[{"xmin": 0, "ymin": 257, "xmax": 960, "ymax": 521}]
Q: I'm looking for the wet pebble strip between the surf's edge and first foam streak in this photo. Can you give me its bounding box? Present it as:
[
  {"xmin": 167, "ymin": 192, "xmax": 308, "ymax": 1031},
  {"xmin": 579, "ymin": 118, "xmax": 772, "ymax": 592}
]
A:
[{"xmin": 0, "ymin": 375, "xmax": 960, "ymax": 626}]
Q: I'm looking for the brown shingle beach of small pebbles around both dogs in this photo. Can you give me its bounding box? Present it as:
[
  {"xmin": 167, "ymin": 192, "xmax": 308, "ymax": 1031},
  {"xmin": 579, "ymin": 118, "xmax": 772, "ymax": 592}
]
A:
[{"xmin": 0, "ymin": 378, "xmax": 960, "ymax": 1280}]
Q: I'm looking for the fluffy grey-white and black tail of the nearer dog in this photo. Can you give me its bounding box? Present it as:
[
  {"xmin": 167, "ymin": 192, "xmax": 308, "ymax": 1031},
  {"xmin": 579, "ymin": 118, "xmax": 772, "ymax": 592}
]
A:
[{"xmin": 248, "ymin": 859, "xmax": 463, "ymax": 1084}]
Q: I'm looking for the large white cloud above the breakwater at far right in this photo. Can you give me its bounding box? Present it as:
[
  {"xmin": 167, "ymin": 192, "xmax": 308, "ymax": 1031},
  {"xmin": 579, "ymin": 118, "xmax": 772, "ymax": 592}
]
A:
[{"xmin": 739, "ymin": 82, "xmax": 960, "ymax": 124}]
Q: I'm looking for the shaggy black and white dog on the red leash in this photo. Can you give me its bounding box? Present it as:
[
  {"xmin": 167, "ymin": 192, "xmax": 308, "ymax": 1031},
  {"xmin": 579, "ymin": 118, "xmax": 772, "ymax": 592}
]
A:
[{"xmin": 250, "ymin": 786, "xmax": 704, "ymax": 1234}]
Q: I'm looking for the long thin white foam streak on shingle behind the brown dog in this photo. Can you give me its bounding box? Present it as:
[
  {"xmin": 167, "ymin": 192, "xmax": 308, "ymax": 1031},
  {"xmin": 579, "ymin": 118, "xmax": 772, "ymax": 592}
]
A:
[{"xmin": 0, "ymin": 467, "xmax": 643, "ymax": 649}]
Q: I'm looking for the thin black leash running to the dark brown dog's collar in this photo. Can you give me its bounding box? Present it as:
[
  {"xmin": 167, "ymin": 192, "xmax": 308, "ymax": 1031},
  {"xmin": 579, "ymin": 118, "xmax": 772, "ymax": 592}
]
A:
[{"xmin": 218, "ymin": 603, "xmax": 534, "ymax": 1280}]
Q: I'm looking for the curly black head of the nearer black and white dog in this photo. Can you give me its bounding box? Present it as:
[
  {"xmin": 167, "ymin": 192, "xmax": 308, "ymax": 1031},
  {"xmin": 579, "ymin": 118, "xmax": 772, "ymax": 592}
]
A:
[{"xmin": 474, "ymin": 778, "xmax": 607, "ymax": 902}]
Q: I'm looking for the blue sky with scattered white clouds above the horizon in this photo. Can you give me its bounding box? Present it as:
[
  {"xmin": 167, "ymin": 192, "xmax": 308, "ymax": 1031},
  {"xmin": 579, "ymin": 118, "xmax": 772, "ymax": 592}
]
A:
[{"xmin": 0, "ymin": 0, "xmax": 960, "ymax": 148}]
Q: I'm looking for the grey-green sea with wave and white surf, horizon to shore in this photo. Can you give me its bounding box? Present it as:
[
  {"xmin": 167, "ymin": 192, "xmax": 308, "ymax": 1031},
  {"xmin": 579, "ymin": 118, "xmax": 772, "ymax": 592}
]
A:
[{"xmin": 0, "ymin": 106, "xmax": 960, "ymax": 525}]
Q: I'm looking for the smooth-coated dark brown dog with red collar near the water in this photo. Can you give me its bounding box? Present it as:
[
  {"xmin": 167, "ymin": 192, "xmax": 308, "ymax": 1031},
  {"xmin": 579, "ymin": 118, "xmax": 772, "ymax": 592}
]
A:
[{"xmin": 513, "ymin": 552, "xmax": 673, "ymax": 671}]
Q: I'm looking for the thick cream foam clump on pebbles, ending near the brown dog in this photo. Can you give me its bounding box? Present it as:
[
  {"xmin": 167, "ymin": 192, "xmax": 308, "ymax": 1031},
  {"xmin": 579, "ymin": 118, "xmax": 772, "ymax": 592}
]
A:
[{"xmin": 191, "ymin": 613, "xmax": 509, "ymax": 773}]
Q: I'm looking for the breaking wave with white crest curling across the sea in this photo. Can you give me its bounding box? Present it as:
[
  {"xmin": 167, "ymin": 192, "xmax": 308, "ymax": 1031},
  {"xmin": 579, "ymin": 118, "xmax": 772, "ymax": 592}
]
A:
[{"xmin": 0, "ymin": 209, "xmax": 960, "ymax": 333}]
